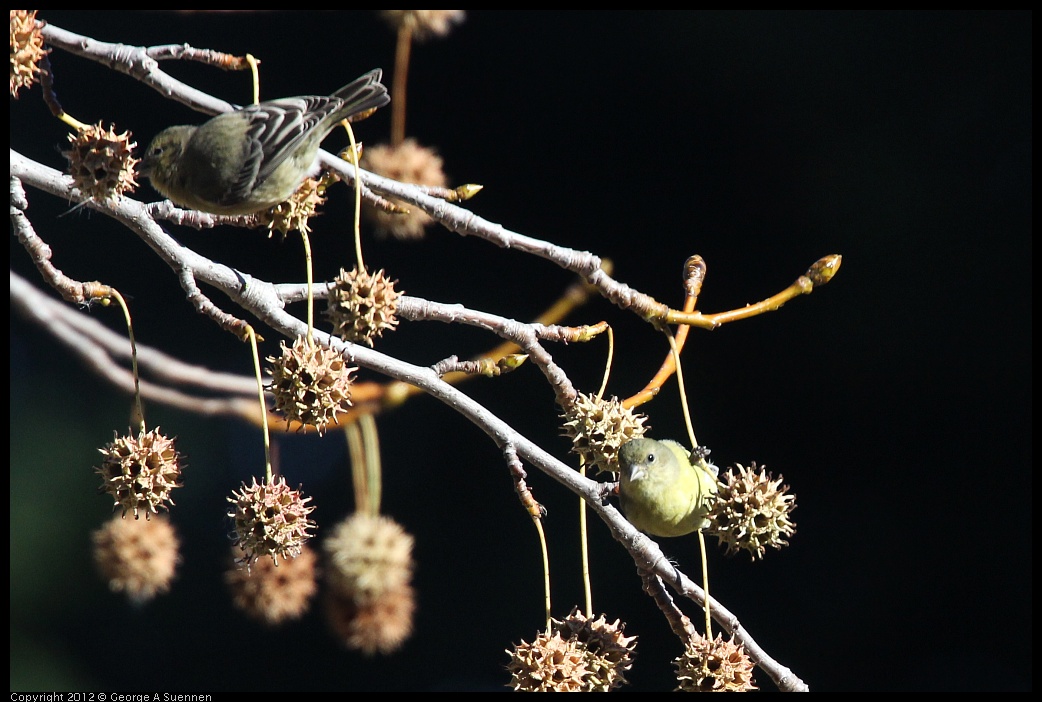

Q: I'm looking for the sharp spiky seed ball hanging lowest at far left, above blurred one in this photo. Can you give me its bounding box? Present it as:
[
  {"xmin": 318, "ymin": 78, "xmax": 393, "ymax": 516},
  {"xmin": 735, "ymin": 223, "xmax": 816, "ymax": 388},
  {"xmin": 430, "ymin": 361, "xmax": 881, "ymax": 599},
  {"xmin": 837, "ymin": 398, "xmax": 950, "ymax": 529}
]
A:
[{"xmin": 94, "ymin": 427, "xmax": 183, "ymax": 519}]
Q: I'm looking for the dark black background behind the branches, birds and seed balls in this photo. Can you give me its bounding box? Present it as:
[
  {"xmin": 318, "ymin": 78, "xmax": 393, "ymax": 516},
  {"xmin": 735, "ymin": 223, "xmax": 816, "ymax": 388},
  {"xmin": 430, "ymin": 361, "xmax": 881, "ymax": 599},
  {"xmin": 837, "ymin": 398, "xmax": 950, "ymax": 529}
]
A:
[{"xmin": 10, "ymin": 11, "xmax": 1033, "ymax": 692}]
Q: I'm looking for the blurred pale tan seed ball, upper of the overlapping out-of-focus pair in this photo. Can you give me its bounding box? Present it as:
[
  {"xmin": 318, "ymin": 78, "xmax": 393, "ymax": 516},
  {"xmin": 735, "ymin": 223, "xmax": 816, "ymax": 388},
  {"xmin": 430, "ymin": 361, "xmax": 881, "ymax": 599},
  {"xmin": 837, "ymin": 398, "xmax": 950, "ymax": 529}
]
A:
[{"xmin": 323, "ymin": 512, "xmax": 413, "ymax": 603}]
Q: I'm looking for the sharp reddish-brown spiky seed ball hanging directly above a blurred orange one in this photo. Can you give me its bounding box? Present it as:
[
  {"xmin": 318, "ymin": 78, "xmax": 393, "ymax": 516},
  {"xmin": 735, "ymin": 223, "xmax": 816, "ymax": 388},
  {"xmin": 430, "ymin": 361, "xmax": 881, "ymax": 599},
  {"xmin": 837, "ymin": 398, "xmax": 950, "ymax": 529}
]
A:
[{"xmin": 228, "ymin": 476, "xmax": 316, "ymax": 566}]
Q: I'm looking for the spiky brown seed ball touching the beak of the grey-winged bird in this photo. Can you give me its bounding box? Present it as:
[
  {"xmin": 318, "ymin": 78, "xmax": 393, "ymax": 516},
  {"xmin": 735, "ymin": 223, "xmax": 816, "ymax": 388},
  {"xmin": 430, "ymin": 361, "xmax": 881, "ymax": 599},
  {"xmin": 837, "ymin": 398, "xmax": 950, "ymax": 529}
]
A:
[{"xmin": 63, "ymin": 122, "xmax": 141, "ymax": 200}]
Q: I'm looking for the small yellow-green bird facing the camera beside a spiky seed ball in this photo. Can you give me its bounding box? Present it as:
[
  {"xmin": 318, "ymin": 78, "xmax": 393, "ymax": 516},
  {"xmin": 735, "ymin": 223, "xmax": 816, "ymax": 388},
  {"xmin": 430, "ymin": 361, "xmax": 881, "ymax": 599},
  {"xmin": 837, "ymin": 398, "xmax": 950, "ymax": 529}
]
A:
[{"xmin": 619, "ymin": 438, "xmax": 718, "ymax": 536}]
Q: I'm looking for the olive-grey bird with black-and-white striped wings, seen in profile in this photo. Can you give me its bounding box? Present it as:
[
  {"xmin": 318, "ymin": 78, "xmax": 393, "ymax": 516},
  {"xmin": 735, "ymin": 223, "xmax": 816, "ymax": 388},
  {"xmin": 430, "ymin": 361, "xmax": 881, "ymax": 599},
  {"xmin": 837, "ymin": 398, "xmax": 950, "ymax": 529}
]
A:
[{"xmin": 139, "ymin": 69, "xmax": 391, "ymax": 215}]
